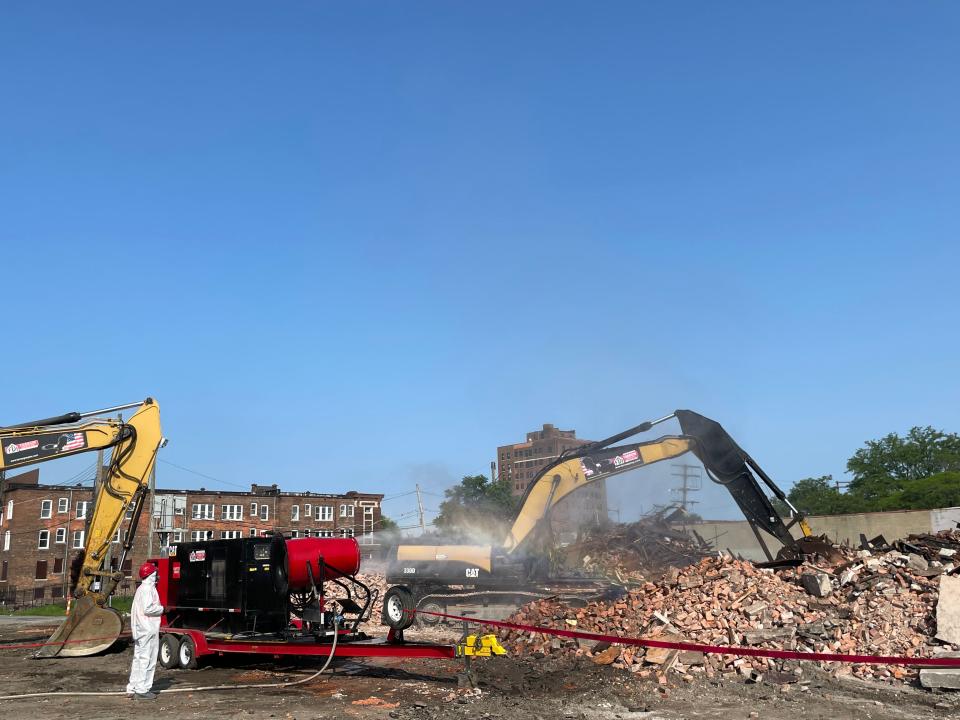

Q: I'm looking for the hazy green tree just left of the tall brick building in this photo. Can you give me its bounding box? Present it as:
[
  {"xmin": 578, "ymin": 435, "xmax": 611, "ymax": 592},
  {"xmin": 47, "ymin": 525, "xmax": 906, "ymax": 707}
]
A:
[{"xmin": 434, "ymin": 475, "xmax": 517, "ymax": 538}]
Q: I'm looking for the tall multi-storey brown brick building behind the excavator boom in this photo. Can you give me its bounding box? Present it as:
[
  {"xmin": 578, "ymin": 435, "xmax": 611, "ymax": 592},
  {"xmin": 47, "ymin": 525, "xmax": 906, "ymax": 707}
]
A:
[{"xmin": 497, "ymin": 423, "xmax": 607, "ymax": 541}]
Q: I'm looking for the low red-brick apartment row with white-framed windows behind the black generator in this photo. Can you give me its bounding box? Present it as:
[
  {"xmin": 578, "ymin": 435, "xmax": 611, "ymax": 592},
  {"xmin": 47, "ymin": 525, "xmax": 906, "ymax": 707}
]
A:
[{"xmin": 0, "ymin": 469, "xmax": 383, "ymax": 602}]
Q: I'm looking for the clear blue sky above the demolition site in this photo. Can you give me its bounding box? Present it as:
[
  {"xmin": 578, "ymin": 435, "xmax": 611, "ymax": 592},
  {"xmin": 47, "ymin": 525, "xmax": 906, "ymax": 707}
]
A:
[{"xmin": 0, "ymin": 2, "xmax": 960, "ymax": 528}]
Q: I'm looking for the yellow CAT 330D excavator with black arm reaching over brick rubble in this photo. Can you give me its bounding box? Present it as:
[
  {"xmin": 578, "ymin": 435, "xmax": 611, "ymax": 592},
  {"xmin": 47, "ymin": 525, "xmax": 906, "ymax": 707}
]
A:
[{"xmin": 383, "ymin": 410, "xmax": 830, "ymax": 630}]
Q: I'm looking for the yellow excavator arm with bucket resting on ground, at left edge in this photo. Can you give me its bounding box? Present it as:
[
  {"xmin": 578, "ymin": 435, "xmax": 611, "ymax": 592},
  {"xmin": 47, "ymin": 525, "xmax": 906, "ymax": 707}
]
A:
[{"xmin": 0, "ymin": 398, "xmax": 166, "ymax": 657}]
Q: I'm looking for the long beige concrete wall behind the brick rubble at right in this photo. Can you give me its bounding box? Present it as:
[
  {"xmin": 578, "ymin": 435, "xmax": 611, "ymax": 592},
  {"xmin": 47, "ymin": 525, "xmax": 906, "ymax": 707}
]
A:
[{"xmin": 690, "ymin": 508, "xmax": 960, "ymax": 560}]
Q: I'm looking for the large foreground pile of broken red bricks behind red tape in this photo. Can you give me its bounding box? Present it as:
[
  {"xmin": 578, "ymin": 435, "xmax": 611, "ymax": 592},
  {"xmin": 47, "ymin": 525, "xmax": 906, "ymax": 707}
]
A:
[{"xmin": 502, "ymin": 550, "xmax": 956, "ymax": 684}]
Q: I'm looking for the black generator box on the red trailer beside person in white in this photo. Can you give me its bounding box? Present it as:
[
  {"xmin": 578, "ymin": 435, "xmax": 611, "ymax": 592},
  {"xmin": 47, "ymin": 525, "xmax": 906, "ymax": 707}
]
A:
[{"xmin": 169, "ymin": 535, "xmax": 290, "ymax": 633}]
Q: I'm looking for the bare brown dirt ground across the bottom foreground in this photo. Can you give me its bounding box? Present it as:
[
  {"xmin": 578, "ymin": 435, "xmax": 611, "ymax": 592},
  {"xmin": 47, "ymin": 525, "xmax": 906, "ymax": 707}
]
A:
[{"xmin": 0, "ymin": 618, "xmax": 960, "ymax": 720}]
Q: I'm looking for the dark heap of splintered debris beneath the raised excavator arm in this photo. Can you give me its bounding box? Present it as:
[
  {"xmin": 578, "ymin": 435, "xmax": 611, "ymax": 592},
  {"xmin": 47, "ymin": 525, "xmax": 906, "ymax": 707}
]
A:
[{"xmin": 567, "ymin": 517, "xmax": 716, "ymax": 584}]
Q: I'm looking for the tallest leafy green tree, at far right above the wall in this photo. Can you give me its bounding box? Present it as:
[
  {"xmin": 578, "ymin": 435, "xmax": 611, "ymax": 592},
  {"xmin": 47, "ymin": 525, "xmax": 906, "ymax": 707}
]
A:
[{"xmin": 847, "ymin": 426, "xmax": 960, "ymax": 504}]
